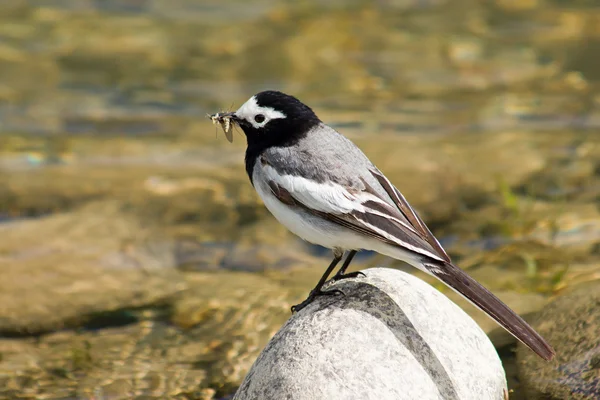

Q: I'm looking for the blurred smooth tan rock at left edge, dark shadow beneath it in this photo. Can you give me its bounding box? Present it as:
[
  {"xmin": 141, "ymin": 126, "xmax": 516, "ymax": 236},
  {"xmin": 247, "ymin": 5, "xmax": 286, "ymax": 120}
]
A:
[{"xmin": 0, "ymin": 203, "xmax": 186, "ymax": 335}]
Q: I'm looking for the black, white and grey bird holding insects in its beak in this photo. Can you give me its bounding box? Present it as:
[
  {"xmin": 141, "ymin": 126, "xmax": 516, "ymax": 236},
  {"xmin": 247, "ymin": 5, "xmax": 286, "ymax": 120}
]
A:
[{"xmin": 213, "ymin": 91, "xmax": 554, "ymax": 360}]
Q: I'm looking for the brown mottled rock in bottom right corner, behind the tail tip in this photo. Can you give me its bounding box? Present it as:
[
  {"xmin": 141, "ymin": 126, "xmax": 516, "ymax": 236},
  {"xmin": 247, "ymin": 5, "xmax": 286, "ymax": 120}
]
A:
[{"xmin": 517, "ymin": 281, "xmax": 600, "ymax": 400}]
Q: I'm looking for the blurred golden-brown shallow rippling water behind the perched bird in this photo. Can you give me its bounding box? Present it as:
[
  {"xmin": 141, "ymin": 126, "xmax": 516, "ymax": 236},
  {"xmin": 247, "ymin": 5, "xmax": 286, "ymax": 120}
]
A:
[{"xmin": 0, "ymin": 0, "xmax": 600, "ymax": 399}]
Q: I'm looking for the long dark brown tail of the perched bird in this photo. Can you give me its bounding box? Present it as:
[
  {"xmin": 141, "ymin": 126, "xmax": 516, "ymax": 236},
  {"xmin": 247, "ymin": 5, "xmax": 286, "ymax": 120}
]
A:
[{"xmin": 423, "ymin": 260, "xmax": 555, "ymax": 361}]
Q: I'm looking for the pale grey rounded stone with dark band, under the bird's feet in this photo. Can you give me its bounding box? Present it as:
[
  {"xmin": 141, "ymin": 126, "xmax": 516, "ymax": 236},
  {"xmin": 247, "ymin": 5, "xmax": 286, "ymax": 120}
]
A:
[{"xmin": 234, "ymin": 268, "xmax": 507, "ymax": 400}]
